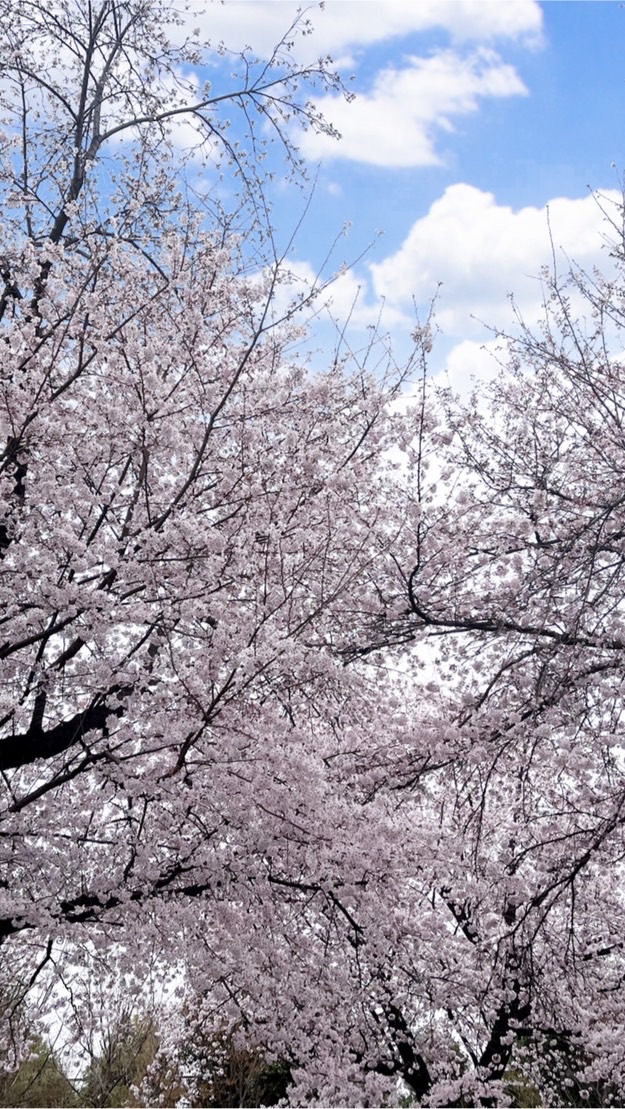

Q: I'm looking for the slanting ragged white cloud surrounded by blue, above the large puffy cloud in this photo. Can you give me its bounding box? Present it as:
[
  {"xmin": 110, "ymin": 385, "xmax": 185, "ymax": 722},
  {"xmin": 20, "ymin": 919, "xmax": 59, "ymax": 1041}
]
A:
[{"xmin": 300, "ymin": 48, "xmax": 527, "ymax": 166}]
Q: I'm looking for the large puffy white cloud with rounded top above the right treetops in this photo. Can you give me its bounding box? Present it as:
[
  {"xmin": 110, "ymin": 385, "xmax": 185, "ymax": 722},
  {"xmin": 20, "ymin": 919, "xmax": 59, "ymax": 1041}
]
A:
[{"xmin": 370, "ymin": 184, "xmax": 619, "ymax": 339}]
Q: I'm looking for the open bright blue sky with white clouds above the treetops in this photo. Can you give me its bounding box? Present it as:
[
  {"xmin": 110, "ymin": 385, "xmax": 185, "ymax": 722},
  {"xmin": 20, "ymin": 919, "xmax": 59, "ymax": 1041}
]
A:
[{"xmin": 181, "ymin": 0, "xmax": 625, "ymax": 383}]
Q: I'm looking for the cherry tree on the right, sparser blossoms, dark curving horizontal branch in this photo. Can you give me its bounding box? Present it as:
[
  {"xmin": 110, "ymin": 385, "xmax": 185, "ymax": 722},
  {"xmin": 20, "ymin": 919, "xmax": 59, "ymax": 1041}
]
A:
[{"xmin": 392, "ymin": 227, "xmax": 625, "ymax": 1105}]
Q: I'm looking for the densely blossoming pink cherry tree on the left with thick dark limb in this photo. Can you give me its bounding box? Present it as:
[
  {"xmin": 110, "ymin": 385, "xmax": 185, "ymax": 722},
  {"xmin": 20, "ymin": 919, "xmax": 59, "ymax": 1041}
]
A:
[{"xmin": 0, "ymin": 0, "xmax": 432, "ymax": 1100}]
